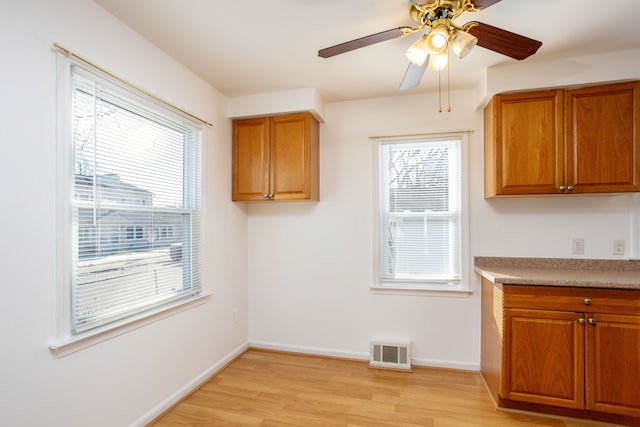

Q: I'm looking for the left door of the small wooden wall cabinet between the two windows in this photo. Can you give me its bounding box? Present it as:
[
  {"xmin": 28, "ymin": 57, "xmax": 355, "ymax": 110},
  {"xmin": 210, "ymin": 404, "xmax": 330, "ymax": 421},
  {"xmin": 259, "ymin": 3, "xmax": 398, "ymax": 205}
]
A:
[{"xmin": 232, "ymin": 118, "xmax": 269, "ymax": 201}]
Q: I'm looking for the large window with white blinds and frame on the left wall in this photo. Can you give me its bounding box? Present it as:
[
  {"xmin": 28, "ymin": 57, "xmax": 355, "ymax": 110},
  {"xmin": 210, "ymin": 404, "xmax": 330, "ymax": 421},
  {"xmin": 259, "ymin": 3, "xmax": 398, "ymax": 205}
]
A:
[{"xmin": 58, "ymin": 57, "xmax": 203, "ymax": 341}]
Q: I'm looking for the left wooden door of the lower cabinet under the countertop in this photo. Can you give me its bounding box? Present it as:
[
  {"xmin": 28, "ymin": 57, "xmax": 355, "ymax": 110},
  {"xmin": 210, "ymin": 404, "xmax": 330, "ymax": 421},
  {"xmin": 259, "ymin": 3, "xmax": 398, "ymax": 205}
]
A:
[{"xmin": 503, "ymin": 309, "xmax": 585, "ymax": 409}]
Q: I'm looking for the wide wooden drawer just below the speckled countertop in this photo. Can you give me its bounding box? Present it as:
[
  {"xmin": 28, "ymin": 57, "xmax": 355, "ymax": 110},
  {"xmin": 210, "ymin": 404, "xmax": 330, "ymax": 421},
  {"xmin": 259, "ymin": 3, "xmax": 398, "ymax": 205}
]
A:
[{"xmin": 504, "ymin": 285, "xmax": 640, "ymax": 315}]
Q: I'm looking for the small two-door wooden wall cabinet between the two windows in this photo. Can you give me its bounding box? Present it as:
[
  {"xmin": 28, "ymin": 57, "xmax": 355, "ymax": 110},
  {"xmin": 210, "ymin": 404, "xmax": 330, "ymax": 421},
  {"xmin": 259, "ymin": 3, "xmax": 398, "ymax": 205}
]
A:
[{"xmin": 232, "ymin": 113, "xmax": 320, "ymax": 201}]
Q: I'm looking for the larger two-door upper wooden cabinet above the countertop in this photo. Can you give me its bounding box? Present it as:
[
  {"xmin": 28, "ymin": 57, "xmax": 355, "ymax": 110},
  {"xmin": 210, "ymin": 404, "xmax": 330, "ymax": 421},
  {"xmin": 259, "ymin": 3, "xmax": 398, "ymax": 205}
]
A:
[{"xmin": 485, "ymin": 82, "xmax": 640, "ymax": 198}]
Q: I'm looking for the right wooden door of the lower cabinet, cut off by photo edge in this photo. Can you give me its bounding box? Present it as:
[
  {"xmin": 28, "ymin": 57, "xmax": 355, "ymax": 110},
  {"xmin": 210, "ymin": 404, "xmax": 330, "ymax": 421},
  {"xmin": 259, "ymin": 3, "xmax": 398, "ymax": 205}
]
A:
[{"xmin": 586, "ymin": 314, "xmax": 640, "ymax": 417}]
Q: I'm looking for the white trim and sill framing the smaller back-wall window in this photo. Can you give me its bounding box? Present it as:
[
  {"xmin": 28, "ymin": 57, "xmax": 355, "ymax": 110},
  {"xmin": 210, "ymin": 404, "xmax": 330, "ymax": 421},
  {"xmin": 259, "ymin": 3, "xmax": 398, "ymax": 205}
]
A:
[{"xmin": 369, "ymin": 131, "xmax": 473, "ymax": 297}]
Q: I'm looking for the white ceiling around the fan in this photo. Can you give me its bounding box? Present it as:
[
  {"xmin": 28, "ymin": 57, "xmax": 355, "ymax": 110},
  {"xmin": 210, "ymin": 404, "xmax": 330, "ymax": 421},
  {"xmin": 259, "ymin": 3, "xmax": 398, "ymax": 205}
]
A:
[{"xmin": 95, "ymin": 0, "xmax": 640, "ymax": 101}]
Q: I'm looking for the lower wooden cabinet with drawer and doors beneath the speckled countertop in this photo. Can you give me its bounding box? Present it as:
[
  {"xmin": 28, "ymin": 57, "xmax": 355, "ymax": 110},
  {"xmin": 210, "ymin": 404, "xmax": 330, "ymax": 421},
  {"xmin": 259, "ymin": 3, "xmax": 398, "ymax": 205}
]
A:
[{"xmin": 481, "ymin": 278, "xmax": 640, "ymax": 425}]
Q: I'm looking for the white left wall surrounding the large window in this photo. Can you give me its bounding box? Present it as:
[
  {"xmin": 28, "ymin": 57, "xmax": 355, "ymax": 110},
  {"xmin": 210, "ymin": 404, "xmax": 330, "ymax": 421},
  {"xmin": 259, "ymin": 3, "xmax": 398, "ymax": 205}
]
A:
[{"xmin": 0, "ymin": 0, "xmax": 248, "ymax": 427}]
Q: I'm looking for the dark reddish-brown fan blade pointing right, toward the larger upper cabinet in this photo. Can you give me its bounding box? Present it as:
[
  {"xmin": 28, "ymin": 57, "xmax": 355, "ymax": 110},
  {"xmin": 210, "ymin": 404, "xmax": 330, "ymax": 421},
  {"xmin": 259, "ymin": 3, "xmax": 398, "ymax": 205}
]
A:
[{"xmin": 469, "ymin": 22, "xmax": 542, "ymax": 60}]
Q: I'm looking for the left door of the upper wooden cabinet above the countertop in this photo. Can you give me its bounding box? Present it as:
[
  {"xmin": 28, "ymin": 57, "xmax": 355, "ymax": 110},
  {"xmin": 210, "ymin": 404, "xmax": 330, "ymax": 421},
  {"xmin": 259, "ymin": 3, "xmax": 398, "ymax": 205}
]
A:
[{"xmin": 485, "ymin": 90, "xmax": 564, "ymax": 196}]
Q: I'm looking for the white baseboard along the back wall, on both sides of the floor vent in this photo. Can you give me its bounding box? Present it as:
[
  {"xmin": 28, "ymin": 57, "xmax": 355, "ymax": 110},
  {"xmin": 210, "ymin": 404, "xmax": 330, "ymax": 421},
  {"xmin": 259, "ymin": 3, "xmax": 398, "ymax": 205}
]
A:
[{"xmin": 249, "ymin": 341, "xmax": 480, "ymax": 372}]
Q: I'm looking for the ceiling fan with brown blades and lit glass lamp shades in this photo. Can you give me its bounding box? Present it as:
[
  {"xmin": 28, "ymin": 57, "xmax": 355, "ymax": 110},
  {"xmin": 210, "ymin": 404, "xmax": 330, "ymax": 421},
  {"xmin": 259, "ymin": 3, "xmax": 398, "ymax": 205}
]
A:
[{"xmin": 318, "ymin": 0, "xmax": 542, "ymax": 90}]
